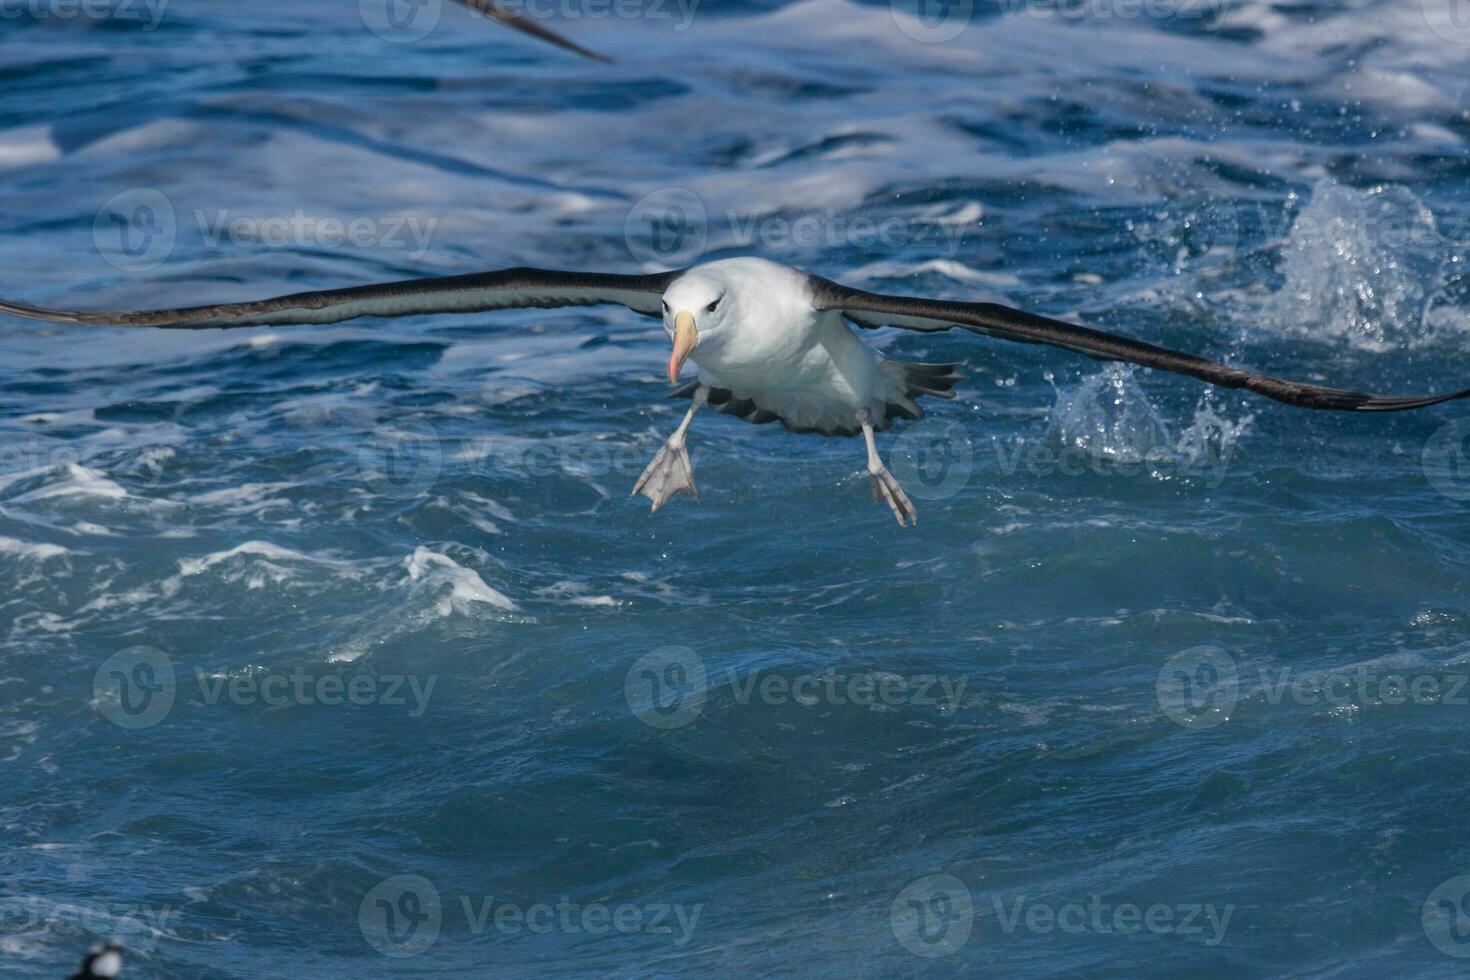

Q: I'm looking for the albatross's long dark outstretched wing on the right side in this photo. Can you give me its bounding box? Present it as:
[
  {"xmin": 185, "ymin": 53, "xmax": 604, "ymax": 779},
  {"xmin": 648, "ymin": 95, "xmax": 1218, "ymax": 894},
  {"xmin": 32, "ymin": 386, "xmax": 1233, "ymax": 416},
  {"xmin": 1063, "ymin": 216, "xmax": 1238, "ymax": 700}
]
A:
[{"xmin": 811, "ymin": 276, "xmax": 1470, "ymax": 411}]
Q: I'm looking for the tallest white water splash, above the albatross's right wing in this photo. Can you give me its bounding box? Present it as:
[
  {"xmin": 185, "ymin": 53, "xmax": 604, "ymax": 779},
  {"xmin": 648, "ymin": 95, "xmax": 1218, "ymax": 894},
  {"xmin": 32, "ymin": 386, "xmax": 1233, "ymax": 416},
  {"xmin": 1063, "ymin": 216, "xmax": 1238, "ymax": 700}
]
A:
[{"xmin": 1266, "ymin": 179, "xmax": 1449, "ymax": 351}]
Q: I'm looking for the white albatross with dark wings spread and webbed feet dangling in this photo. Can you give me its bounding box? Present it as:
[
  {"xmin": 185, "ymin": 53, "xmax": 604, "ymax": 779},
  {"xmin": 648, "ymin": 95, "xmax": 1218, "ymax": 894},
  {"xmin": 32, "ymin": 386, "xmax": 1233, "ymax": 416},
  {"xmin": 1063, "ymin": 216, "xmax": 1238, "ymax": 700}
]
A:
[{"xmin": 0, "ymin": 259, "xmax": 1470, "ymax": 525}]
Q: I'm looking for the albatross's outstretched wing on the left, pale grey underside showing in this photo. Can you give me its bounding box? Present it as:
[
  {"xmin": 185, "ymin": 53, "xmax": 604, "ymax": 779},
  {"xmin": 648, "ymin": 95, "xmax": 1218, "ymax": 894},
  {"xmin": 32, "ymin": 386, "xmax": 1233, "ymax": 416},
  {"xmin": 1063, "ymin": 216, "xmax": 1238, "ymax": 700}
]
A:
[{"xmin": 0, "ymin": 269, "xmax": 682, "ymax": 329}]
